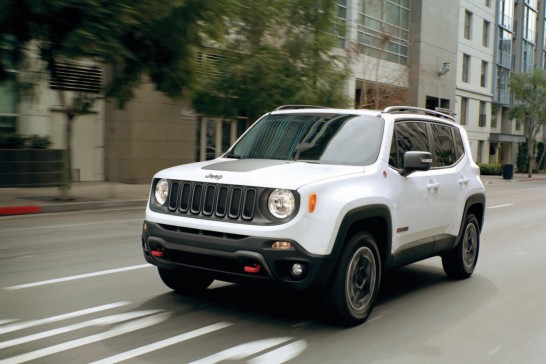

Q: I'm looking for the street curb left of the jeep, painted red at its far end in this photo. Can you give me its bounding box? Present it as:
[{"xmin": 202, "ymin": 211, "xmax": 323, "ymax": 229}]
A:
[{"xmin": 0, "ymin": 200, "xmax": 148, "ymax": 216}]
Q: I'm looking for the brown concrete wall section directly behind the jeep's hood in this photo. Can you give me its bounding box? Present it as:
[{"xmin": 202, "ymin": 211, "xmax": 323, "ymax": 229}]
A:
[{"xmin": 104, "ymin": 83, "xmax": 197, "ymax": 183}]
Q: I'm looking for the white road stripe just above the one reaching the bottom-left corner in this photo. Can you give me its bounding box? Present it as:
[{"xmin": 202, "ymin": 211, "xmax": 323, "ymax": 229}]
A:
[{"xmin": 0, "ymin": 310, "xmax": 161, "ymax": 349}]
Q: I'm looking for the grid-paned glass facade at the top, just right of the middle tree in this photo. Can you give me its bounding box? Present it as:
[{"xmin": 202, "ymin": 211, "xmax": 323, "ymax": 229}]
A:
[{"xmin": 357, "ymin": 0, "xmax": 410, "ymax": 64}]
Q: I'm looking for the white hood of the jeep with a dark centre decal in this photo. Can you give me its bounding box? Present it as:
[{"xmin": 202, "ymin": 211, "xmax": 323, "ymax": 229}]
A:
[{"xmin": 155, "ymin": 158, "xmax": 364, "ymax": 190}]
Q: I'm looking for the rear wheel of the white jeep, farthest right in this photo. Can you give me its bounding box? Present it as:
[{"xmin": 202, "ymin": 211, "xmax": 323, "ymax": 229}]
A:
[{"xmin": 442, "ymin": 214, "xmax": 480, "ymax": 279}]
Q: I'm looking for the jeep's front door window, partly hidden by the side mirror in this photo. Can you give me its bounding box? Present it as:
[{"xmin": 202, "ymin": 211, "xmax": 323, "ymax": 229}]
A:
[{"xmin": 389, "ymin": 121, "xmax": 429, "ymax": 168}]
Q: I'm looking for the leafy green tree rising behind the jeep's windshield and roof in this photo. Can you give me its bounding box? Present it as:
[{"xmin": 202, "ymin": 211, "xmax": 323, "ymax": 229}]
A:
[{"xmin": 194, "ymin": 0, "xmax": 348, "ymax": 122}]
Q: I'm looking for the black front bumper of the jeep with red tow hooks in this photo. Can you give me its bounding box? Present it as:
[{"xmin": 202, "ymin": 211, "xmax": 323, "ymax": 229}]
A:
[{"xmin": 142, "ymin": 221, "xmax": 333, "ymax": 290}]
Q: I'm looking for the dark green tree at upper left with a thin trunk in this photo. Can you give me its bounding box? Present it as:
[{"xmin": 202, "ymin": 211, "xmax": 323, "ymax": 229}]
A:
[{"xmin": 0, "ymin": 0, "xmax": 228, "ymax": 196}]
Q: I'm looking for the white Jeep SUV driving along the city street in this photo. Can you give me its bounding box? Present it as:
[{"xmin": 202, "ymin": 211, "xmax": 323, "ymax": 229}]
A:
[{"xmin": 142, "ymin": 106, "xmax": 485, "ymax": 325}]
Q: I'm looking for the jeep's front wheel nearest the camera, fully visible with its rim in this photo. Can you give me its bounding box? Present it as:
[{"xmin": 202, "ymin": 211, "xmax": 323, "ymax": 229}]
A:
[{"xmin": 328, "ymin": 232, "xmax": 381, "ymax": 326}]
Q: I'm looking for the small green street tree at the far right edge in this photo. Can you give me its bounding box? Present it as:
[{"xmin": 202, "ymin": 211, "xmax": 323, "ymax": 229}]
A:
[{"xmin": 509, "ymin": 69, "xmax": 546, "ymax": 177}]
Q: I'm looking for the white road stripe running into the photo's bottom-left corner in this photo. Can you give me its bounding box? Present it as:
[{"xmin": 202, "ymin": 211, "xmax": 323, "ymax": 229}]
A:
[{"xmin": 0, "ymin": 313, "xmax": 170, "ymax": 364}]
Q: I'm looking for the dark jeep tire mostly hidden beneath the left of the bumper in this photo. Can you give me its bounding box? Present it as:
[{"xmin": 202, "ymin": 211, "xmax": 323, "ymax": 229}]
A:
[{"xmin": 157, "ymin": 267, "xmax": 214, "ymax": 294}]
